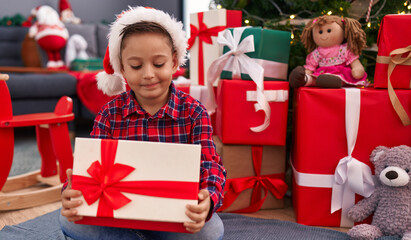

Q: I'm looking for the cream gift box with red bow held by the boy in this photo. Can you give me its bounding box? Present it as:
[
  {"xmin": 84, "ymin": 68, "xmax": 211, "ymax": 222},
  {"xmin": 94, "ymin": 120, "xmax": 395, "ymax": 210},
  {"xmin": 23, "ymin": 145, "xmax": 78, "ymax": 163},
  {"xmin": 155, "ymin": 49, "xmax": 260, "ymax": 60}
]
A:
[{"xmin": 72, "ymin": 138, "xmax": 201, "ymax": 232}]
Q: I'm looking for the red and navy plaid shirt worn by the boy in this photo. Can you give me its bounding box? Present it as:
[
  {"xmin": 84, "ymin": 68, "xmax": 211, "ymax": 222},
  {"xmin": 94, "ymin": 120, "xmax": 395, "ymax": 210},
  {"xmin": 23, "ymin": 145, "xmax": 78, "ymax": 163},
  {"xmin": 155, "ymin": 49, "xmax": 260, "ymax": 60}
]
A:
[{"xmin": 90, "ymin": 83, "xmax": 226, "ymax": 211}]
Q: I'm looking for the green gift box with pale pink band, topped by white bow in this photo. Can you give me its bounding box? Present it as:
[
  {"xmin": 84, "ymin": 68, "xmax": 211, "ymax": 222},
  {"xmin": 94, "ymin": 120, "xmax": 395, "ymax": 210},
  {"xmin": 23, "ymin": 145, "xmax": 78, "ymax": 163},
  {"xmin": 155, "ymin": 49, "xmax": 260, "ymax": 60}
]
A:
[{"xmin": 220, "ymin": 27, "xmax": 291, "ymax": 81}]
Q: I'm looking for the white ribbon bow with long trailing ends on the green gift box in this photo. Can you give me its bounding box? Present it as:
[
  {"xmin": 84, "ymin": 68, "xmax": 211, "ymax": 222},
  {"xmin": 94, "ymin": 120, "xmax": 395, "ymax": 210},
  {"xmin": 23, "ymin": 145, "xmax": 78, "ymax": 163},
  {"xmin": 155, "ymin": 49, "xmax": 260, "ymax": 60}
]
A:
[{"xmin": 207, "ymin": 27, "xmax": 271, "ymax": 132}]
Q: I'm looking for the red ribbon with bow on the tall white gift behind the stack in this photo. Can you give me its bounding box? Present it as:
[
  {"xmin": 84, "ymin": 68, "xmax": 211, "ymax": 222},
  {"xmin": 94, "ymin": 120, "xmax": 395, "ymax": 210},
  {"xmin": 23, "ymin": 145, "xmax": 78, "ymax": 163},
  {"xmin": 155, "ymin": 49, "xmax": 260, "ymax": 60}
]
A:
[{"xmin": 188, "ymin": 12, "xmax": 226, "ymax": 85}]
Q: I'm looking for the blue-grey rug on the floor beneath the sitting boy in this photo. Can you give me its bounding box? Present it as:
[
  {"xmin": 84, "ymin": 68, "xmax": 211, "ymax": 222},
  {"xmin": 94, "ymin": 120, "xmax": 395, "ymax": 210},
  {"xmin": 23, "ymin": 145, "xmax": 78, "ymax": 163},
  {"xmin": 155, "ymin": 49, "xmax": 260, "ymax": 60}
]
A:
[{"xmin": 0, "ymin": 209, "xmax": 399, "ymax": 240}]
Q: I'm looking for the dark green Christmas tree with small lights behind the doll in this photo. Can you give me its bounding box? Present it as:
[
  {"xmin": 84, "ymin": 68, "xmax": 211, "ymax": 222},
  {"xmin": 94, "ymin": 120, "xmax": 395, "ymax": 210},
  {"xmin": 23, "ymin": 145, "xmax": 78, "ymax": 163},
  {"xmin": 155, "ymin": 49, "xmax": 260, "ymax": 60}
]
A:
[{"xmin": 213, "ymin": 0, "xmax": 411, "ymax": 82}]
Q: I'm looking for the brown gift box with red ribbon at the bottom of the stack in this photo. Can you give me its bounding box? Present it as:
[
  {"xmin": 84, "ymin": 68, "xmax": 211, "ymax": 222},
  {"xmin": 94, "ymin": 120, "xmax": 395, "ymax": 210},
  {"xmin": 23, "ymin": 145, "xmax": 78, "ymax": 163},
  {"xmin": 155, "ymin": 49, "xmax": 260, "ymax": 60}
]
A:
[{"xmin": 214, "ymin": 136, "xmax": 287, "ymax": 212}]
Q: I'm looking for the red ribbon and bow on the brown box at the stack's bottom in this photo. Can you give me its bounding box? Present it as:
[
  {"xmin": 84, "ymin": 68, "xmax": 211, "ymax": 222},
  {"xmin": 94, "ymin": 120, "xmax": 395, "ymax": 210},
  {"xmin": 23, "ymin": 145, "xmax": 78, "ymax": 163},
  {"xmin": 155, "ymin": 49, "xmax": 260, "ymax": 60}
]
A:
[{"xmin": 220, "ymin": 146, "xmax": 288, "ymax": 213}]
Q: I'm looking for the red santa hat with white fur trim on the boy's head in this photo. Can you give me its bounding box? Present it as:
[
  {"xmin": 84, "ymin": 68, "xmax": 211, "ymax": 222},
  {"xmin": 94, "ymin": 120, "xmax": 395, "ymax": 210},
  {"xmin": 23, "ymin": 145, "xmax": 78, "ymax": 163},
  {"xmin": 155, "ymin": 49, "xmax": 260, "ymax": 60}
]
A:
[{"xmin": 96, "ymin": 7, "xmax": 187, "ymax": 96}]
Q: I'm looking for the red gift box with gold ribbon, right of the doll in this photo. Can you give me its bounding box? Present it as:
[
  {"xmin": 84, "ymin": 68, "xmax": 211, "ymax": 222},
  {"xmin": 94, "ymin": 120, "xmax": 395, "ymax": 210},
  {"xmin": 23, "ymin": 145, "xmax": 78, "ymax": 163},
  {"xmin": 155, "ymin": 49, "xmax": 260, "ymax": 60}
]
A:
[{"xmin": 374, "ymin": 14, "xmax": 411, "ymax": 89}]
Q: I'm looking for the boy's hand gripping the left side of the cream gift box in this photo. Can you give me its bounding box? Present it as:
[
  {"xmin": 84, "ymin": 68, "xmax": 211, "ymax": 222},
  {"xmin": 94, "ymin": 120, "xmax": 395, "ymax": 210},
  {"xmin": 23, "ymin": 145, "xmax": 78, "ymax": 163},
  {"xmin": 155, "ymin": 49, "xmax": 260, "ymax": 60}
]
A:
[{"xmin": 61, "ymin": 169, "xmax": 83, "ymax": 222}]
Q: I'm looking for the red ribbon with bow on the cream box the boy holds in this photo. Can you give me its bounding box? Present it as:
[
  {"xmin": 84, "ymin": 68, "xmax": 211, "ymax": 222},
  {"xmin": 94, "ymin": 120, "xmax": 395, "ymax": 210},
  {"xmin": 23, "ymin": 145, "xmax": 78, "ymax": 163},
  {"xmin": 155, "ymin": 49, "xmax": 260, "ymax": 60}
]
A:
[{"xmin": 73, "ymin": 139, "xmax": 198, "ymax": 217}]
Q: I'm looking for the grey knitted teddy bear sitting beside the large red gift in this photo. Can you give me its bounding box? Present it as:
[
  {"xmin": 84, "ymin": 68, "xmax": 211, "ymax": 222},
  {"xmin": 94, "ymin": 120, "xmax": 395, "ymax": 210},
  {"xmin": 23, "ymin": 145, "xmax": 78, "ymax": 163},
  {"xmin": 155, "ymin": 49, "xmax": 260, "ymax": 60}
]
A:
[{"xmin": 347, "ymin": 145, "xmax": 411, "ymax": 240}]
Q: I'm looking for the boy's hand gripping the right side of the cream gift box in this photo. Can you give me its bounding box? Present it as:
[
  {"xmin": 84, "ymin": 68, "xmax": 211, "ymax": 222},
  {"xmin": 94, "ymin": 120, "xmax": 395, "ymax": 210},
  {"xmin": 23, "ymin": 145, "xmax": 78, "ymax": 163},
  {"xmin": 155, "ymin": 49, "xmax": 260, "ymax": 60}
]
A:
[{"xmin": 184, "ymin": 189, "xmax": 211, "ymax": 233}]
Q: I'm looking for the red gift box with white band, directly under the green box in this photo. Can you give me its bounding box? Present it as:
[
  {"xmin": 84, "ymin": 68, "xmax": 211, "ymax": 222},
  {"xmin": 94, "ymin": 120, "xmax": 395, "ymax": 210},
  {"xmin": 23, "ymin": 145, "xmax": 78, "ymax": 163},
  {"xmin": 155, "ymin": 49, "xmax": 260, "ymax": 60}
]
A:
[{"xmin": 216, "ymin": 80, "xmax": 289, "ymax": 145}]
